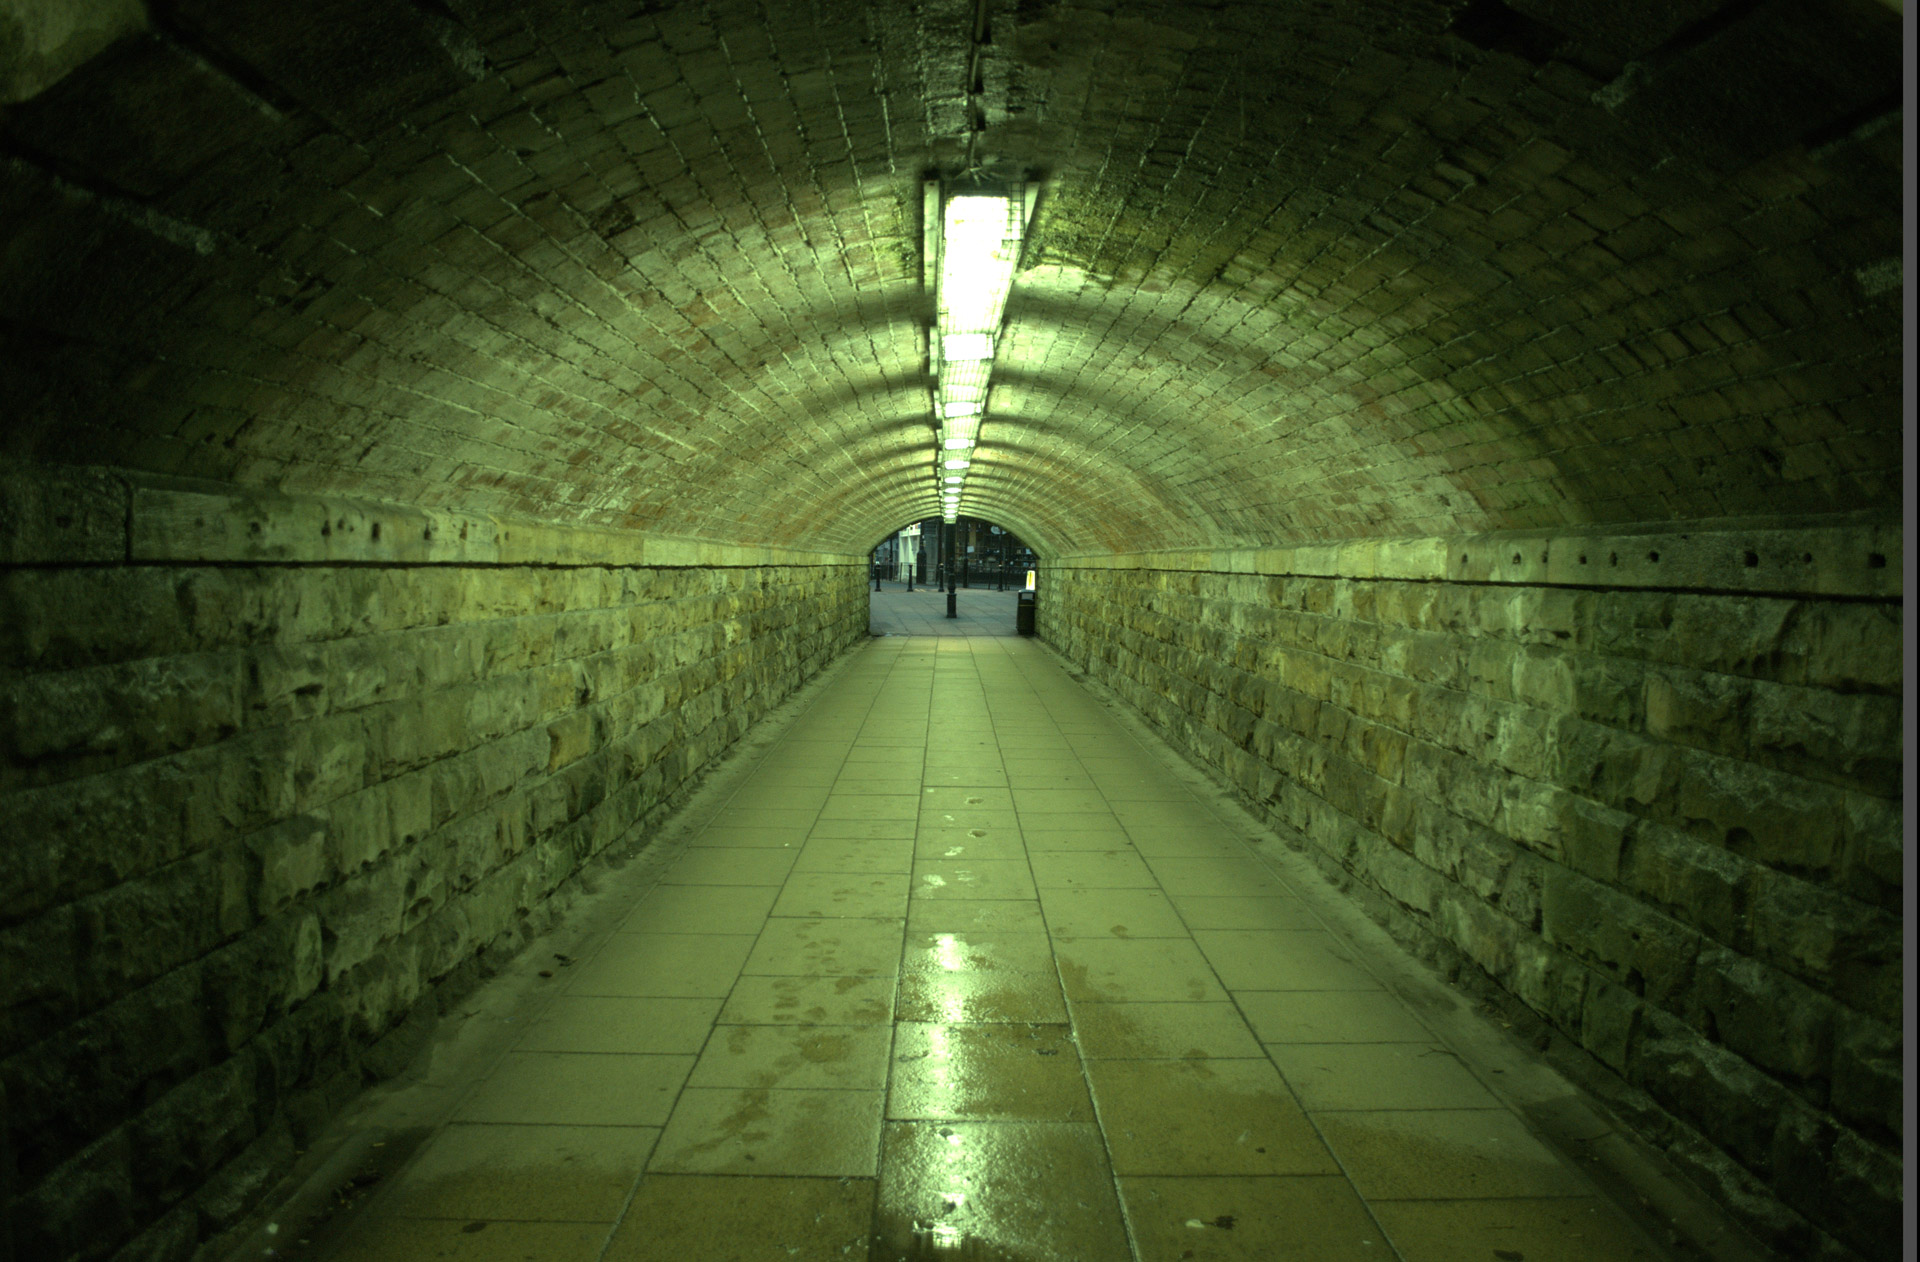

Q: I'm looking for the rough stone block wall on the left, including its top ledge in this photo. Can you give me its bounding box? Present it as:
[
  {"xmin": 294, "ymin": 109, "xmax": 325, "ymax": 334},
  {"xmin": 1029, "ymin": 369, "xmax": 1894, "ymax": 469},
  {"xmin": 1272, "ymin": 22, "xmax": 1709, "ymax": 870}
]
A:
[{"xmin": 0, "ymin": 464, "xmax": 868, "ymax": 1260}]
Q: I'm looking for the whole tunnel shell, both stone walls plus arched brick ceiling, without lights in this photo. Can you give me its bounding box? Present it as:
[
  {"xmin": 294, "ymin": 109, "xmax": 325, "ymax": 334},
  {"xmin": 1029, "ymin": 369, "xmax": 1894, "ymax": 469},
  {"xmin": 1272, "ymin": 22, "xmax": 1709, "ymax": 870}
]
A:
[{"xmin": 0, "ymin": 0, "xmax": 1910, "ymax": 1262}]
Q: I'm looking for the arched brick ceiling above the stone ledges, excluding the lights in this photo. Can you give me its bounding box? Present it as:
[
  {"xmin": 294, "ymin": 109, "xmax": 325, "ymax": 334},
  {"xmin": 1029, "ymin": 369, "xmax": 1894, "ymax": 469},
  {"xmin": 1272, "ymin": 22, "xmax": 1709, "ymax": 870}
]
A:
[{"xmin": 0, "ymin": 0, "xmax": 1903, "ymax": 551}]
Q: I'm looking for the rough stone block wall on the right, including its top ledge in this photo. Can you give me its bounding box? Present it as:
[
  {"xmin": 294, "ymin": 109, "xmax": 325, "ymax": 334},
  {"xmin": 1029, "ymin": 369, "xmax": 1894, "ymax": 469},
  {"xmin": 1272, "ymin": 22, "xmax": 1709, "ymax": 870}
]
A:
[{"xmin": 1039, "ymin": 524, "xmax": 1903, "ymax": 1260}]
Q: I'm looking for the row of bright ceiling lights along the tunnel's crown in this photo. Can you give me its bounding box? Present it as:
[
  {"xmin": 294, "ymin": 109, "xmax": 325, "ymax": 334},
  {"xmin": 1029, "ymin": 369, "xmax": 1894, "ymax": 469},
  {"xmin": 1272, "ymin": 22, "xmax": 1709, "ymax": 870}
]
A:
[{"xmin": 927, "ymin": 181, "xmax": 1031, "ymax": 522}]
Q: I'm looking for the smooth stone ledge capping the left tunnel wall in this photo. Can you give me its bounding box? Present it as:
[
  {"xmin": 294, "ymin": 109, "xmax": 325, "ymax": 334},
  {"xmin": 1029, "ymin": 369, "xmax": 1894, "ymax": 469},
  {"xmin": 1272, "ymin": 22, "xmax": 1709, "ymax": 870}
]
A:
[{"xmin": 0, "ymin": 465, "xmax": 866, "ymax": 569}]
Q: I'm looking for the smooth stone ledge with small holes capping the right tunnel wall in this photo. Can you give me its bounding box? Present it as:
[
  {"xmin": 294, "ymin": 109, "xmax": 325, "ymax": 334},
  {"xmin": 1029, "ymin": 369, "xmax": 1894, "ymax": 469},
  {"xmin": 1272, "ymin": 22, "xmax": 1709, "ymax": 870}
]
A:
[{"xmin": 1043, "ymin": 521, "xmax": 1903, "ymax": 599}]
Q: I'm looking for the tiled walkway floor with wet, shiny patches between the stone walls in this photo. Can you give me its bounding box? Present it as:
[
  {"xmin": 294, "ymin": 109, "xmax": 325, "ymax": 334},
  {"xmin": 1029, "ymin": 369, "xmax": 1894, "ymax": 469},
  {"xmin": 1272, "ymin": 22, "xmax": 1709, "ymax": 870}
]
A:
[{"xmin": 314, "ymin": 638, "xmax": 1665, "ymax": 1262}]
